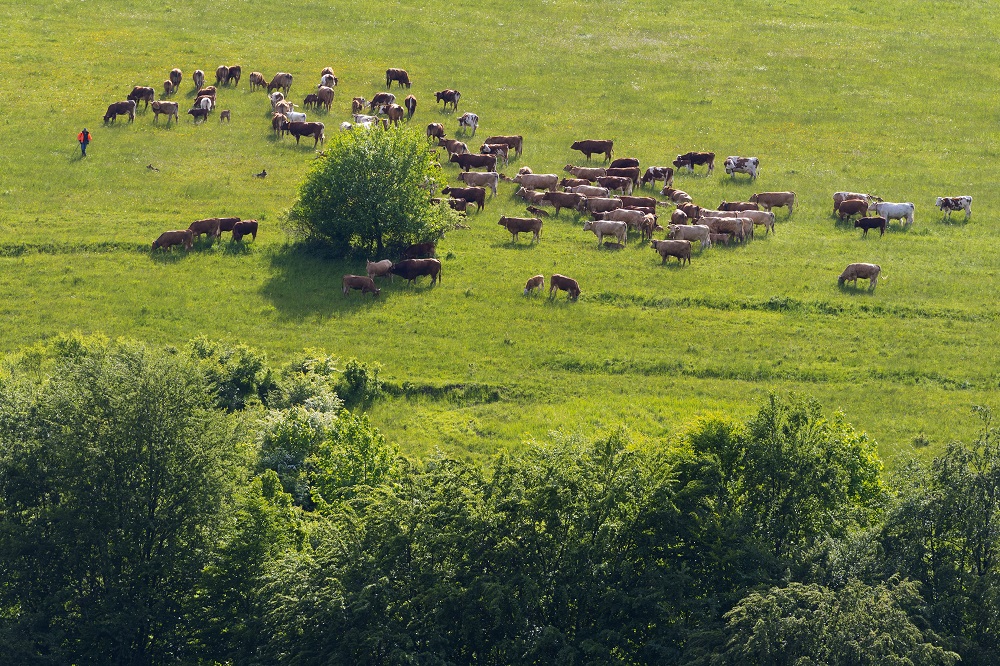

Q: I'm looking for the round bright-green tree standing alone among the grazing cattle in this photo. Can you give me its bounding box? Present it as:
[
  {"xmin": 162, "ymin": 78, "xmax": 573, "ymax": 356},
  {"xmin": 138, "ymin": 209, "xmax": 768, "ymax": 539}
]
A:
[{"xmin": 290, "ymin": 128, "xmax": 451, "ymax": 257}]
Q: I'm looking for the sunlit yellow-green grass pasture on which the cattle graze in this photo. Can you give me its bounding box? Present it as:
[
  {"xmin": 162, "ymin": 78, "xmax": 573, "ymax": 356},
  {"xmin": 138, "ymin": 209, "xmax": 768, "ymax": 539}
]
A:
[{"xmin": 0, "ymin": 0, "xmax": 1000, "ymax": 459}]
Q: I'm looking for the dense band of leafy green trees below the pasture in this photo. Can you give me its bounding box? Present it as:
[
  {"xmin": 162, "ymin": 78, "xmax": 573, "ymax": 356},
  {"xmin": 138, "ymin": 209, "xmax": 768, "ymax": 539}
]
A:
[{"xmin": 0, "ymin": 336, "xmax": 1000, "ymax": 666}]
